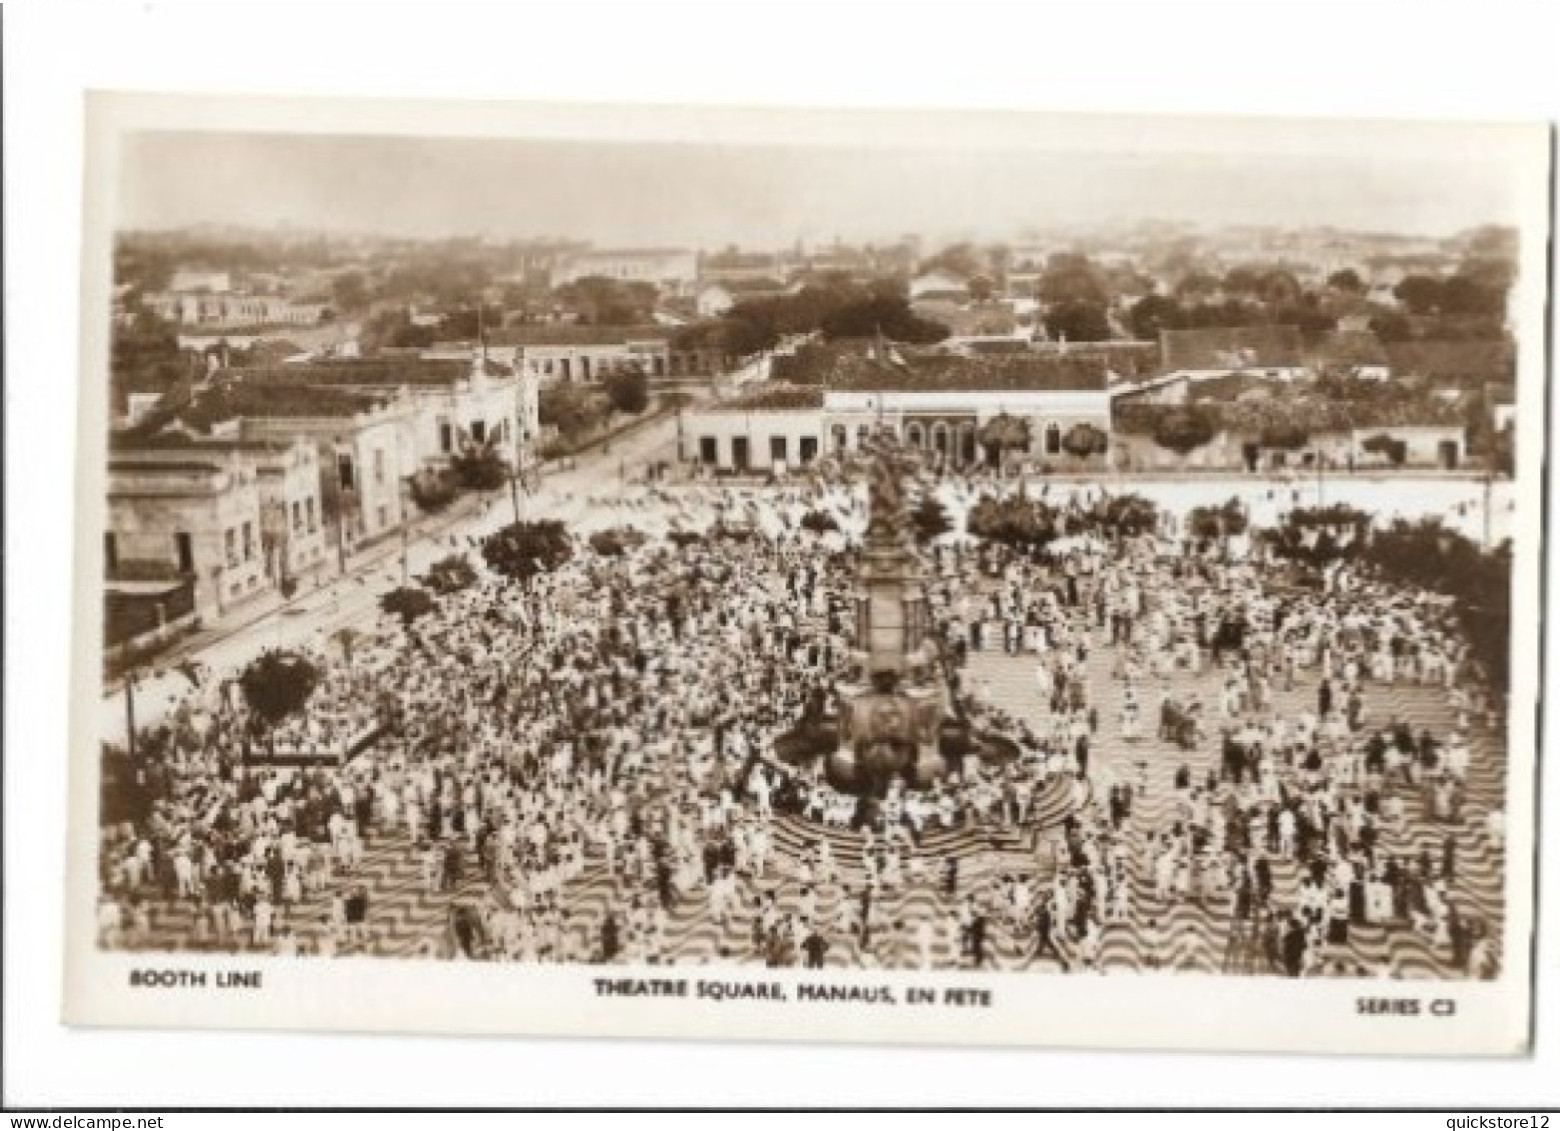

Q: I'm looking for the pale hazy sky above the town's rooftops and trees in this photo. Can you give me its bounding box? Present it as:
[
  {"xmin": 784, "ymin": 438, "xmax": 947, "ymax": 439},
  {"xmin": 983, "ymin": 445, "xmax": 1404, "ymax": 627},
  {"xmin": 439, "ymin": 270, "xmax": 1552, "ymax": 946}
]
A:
[{"xmin": 120, "ymin": 133, "xmax": 1515, "ymax": 246}]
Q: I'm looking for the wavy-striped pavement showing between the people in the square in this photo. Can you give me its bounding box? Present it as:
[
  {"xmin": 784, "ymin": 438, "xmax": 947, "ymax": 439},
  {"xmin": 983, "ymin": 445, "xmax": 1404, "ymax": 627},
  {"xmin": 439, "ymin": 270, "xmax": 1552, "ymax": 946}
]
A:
[{"xmin": 100, "ymin": 471, "xmax": 1505, "ymax": 978}]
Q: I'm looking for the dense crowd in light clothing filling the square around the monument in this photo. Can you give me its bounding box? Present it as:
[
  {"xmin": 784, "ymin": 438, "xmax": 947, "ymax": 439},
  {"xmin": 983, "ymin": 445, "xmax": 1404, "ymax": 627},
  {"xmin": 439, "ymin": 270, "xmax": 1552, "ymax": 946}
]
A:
[{"xmin": 91, "ymin": 461, "xmax": 1499, "ymax": 975}]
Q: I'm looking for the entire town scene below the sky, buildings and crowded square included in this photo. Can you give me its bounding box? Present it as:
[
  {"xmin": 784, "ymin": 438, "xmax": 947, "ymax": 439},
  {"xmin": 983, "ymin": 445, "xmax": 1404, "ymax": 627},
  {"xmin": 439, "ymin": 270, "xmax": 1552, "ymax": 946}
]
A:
[{"xmin": 95, "ymin": 127, "xmax": 1518, "ymax": 984}]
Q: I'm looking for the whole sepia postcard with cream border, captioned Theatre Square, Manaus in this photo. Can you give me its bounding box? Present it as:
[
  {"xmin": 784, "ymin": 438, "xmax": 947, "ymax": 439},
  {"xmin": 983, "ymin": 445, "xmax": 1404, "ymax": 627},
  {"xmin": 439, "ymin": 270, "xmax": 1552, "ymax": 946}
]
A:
[{"xmin": 57, "ymin": 95, "xmax": 1551, "ymax": 1055}]
